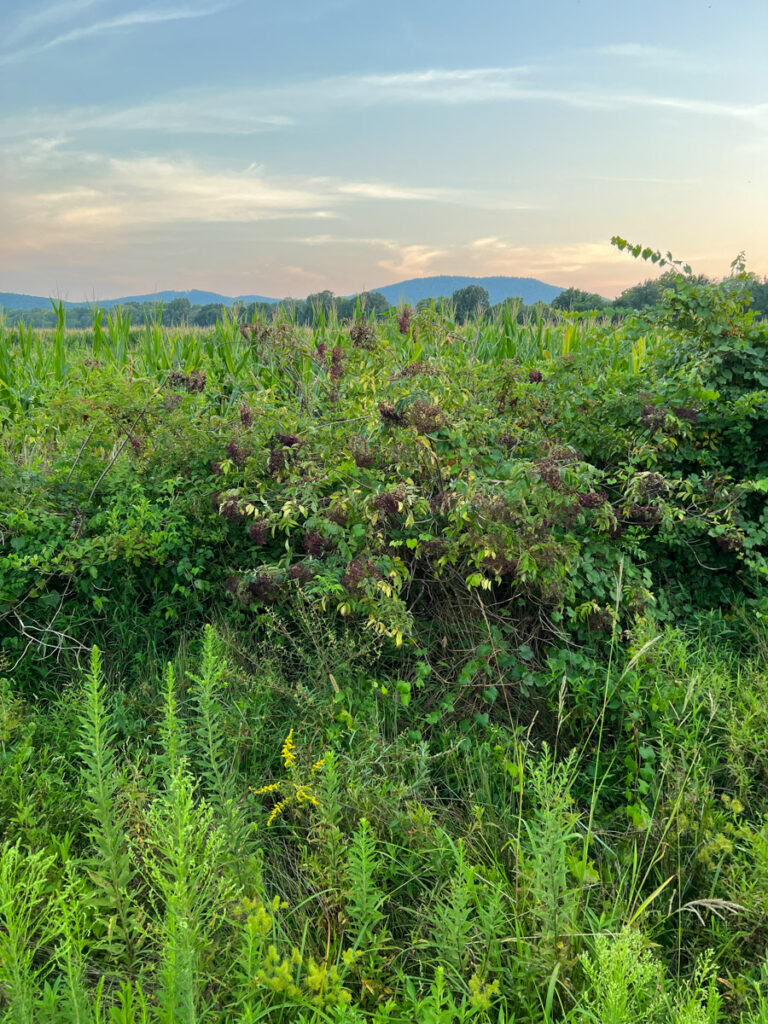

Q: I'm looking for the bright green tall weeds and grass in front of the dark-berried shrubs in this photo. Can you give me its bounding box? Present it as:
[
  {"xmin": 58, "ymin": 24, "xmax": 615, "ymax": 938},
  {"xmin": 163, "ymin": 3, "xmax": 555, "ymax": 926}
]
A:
[{"xmin": 0, "ymin": 629, "xmax": 768, "ymax": 1024}]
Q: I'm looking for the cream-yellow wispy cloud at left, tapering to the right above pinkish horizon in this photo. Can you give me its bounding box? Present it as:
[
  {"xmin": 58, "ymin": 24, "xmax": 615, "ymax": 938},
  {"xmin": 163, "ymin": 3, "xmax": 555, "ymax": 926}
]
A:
[{"xmin": 4, "ymin": 147, "xmax": 536, "ymax": 238}]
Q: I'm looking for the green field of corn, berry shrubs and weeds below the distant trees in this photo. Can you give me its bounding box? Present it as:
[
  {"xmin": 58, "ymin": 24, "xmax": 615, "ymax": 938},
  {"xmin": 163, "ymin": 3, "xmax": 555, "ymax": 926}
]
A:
[{"xmin": 0, "ymin": 260, "xmax": 768, "ymax": 1024}]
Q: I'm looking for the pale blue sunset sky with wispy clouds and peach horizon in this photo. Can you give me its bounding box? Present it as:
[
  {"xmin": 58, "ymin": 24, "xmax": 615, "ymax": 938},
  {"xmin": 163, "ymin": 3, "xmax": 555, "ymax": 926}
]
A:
[{"xmin": 0, "ymin": 0, "xmax": 768, "ymax": 301}]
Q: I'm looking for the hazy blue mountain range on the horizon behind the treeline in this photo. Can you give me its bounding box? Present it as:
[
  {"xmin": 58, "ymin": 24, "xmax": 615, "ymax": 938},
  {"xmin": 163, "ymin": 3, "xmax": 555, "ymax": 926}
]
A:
[{"xmin": 0, "ymin": 274, "xmax": 562, "ymax": 309}]
